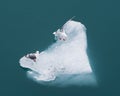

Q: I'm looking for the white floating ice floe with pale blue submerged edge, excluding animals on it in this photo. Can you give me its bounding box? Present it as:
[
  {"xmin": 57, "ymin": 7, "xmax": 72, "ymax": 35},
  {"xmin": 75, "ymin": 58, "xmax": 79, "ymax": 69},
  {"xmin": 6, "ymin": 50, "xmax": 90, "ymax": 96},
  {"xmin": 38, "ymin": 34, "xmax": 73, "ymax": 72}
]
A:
[{"xmin": 20, "ymin": 20, "xmax": 96, "ymax": 86}]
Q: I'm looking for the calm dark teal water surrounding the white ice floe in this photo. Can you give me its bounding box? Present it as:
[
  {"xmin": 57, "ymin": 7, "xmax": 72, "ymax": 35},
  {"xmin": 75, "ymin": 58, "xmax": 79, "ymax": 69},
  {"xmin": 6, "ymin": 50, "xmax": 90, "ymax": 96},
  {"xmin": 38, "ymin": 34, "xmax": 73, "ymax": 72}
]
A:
[{"xmin": 0, "ymin": 0, "xmax": 120, "ymax": 96}]
